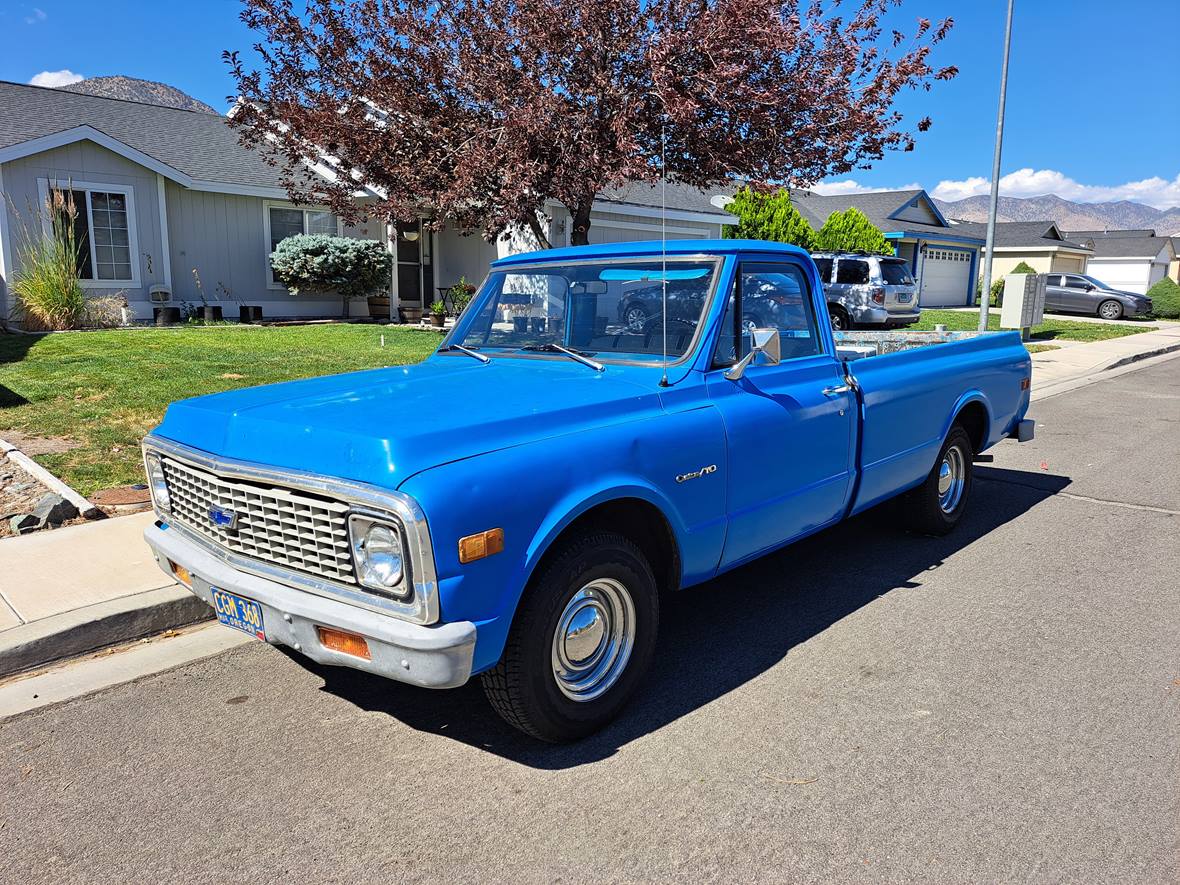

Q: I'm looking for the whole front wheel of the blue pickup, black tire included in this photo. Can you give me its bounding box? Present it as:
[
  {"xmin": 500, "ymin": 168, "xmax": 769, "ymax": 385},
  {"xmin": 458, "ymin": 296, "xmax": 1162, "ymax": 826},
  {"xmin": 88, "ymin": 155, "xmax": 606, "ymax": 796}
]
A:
[{"xmin": 481, "ymin": 532, "xmax": 660, "ymax": 743}]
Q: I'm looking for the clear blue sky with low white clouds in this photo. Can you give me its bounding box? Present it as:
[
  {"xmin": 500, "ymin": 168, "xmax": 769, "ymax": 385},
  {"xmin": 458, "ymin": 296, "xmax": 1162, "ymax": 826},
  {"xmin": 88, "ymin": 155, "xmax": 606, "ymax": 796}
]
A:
[{"xmin": 0, "ymin": 0, "xmax": 1180, "ymax": 209}]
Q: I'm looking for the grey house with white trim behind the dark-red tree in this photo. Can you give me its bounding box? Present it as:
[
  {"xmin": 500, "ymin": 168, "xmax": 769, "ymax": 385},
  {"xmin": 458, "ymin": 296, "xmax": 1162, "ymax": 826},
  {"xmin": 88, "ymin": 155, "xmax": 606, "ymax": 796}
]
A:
[{"xmin": 0, "ymin": 81, "xmax": 733, "ymax": 320}]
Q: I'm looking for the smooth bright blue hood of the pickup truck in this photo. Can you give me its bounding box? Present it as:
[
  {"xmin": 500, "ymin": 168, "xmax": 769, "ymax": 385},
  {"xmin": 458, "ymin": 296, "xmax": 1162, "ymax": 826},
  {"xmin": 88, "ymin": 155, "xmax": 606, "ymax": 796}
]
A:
[{"xmin": 156, "ymin": 355, "xmax": 661, "ymax": 489}]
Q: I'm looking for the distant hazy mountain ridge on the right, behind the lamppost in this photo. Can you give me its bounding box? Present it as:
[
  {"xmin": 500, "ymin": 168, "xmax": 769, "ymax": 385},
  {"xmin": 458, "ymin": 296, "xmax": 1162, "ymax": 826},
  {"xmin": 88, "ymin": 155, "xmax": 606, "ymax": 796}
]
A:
[{"xmin": 935, "ymin": 194, "xmax": 1180, "ymax": 236}]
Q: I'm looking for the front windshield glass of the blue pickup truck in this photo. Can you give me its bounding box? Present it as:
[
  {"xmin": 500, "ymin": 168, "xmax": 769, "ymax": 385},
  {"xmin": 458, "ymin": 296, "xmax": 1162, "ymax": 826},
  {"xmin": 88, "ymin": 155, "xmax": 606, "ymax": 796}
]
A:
[{"xmin": 452, "ymin": 258, "xmax": 717, "ymax": 362}]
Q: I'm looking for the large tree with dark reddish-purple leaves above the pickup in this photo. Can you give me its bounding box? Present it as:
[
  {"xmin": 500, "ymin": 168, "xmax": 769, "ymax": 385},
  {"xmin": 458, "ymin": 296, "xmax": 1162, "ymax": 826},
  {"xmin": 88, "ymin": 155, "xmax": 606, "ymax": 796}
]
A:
[{"xmin": 224, "ymin": 0, "xmax": 957, "ymax": 245}]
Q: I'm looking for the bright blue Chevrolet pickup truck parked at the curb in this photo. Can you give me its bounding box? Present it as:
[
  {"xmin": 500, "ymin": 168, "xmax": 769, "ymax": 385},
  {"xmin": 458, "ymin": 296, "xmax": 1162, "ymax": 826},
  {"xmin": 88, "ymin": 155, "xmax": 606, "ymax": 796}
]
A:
[{"xmin": 144, "ymin": 240, "xmax": 1031, "ymax": 741}]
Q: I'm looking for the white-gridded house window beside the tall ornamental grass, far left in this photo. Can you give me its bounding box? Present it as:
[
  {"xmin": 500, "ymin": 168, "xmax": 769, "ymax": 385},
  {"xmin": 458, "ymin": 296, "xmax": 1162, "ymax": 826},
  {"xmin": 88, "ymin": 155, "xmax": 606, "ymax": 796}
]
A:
[{"xmin": 53, "ymin": 188, "xmax": 135, "ymax": 282}]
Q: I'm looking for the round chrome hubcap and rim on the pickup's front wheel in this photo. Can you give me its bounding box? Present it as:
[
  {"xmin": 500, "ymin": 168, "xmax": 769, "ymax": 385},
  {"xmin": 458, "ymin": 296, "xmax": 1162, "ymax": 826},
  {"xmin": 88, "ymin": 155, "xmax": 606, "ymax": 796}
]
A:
[{"xmin": 552, "ymin": 578, "xmax": 635, "ymax": 701}]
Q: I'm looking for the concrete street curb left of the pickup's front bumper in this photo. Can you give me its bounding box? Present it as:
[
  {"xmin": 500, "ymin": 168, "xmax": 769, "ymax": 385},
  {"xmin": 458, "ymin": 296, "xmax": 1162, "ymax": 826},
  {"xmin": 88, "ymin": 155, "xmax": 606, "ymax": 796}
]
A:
[{"xmin": 0, "ymin": 584, "xmax": 212, "ymax": 676}]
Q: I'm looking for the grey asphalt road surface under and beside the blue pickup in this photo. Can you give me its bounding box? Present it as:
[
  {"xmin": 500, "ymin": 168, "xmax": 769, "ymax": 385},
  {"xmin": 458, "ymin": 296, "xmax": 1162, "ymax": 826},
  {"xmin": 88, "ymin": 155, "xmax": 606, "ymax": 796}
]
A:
[{"xmin": 0, "ymin": 360, "xmax": 1180, "ymax": 883}]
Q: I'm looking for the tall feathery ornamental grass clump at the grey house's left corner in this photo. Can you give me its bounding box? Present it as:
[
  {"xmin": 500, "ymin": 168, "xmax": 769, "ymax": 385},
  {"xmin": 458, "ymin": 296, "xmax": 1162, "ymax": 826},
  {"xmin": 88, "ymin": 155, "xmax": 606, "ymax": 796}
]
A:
[{"xmin": 12, "ymin": 191, "xmax": 86, "ymax": 329}]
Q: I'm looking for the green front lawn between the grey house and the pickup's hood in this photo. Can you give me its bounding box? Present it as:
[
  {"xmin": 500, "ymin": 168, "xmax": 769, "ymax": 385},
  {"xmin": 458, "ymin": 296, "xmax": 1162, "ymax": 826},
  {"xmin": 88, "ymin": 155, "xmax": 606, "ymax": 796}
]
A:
[{"xmin": 0, "ymin": 325, "xmax": 439, "ymax": 494}]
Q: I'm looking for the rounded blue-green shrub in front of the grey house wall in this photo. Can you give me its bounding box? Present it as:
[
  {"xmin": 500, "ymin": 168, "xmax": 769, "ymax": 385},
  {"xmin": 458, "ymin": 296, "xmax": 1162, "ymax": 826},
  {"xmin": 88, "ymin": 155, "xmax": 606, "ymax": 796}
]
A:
[{"xmin": 270, "ymin": 234, "xmax": 393, "ymax": 314}]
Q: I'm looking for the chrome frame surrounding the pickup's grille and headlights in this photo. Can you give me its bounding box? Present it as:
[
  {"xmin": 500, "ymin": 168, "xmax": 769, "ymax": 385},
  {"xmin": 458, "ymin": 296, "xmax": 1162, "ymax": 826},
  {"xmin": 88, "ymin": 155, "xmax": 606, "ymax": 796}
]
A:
[{"xmin": 143, "ymin": 434, "xmax": 439, "ymax": 624}]
